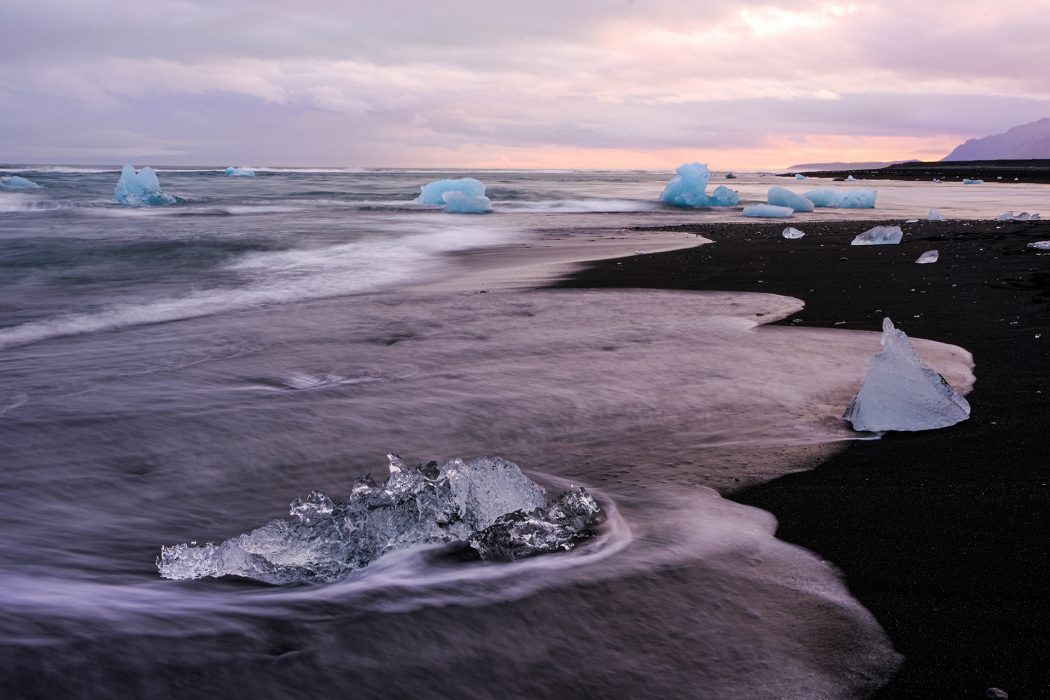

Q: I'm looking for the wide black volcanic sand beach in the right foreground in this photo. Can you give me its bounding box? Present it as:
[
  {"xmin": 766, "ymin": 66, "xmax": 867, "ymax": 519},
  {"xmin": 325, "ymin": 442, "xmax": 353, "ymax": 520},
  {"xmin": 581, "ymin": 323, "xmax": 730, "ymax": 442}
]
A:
[{"xmin": 563, "ymin": 221, "xmax": 1050, "ymax": 699}]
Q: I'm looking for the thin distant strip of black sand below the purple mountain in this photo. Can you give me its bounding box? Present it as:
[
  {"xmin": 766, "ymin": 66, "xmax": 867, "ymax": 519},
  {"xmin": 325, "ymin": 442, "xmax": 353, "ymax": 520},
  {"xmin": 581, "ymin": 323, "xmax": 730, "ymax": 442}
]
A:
[{"xmin": 780, "ymin": 160, "xmax": 1050, "ymax": 184}]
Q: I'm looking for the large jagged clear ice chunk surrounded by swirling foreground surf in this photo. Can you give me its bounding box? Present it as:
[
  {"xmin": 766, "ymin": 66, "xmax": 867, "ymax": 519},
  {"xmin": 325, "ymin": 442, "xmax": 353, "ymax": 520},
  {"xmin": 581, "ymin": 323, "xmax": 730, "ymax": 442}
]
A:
[{"xmin": 156, "ymin": 454, "xmax": 599, "ymax": 584}]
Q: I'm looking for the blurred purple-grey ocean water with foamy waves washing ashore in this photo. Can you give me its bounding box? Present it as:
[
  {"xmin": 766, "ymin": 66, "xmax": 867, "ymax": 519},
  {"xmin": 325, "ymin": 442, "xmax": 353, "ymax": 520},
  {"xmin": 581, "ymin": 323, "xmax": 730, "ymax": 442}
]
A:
[{"xmin": 0, "ymin": 166, "xmax": 1003, "ymax": 698}]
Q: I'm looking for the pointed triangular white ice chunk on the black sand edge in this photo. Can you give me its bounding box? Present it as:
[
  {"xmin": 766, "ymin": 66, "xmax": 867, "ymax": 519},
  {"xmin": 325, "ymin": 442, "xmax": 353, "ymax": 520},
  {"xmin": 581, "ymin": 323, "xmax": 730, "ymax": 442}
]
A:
[{"xmin": 842, "ymin": 318, "xmax": 970, "ymax": 431}]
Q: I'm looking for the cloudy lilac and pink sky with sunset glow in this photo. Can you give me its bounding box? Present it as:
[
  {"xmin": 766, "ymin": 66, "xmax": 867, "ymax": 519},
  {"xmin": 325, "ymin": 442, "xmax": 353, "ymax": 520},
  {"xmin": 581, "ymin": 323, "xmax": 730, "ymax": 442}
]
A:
[{"xmin": 0, "ymin": 0, "xmax": 1050, "ymax": 169}]
